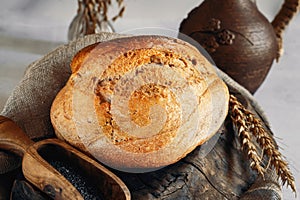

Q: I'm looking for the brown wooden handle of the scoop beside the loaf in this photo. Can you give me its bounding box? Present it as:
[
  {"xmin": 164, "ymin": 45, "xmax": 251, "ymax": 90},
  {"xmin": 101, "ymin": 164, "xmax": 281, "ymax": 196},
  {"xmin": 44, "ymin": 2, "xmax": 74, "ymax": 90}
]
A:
[{"xmin": 0, "ymin": 116, "xmax": 33, "ymax": 157}]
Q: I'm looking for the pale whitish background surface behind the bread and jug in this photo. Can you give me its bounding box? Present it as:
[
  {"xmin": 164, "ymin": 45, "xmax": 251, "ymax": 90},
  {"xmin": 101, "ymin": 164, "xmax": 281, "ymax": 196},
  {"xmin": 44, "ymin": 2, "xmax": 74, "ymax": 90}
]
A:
[{"xmin": 0, "ymin": 0, "xmax": 300, "ymax": 199}]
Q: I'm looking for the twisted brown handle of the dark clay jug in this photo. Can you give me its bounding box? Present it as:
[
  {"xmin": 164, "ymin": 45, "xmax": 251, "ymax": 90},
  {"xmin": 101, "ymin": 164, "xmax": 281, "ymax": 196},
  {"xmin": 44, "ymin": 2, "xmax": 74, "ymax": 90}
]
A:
[{"xmin": 272, "ymin": 0, "xmax": 300, "ymax": 61}]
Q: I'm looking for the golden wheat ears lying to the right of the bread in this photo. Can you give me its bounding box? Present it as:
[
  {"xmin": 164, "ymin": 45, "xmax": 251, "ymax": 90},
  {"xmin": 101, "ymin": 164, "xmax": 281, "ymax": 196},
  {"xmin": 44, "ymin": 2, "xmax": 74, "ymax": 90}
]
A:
[{"xmin": 229, "ymin": 95, "xmax": 296, "ymax": 193}]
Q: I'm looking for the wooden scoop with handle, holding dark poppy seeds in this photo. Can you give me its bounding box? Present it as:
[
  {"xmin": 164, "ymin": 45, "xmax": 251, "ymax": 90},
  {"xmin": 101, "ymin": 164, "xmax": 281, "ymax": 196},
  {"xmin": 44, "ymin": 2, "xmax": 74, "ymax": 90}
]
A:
[{"xmin": 0, "ymin": 116, "xmax": 131, "ymax": 200}]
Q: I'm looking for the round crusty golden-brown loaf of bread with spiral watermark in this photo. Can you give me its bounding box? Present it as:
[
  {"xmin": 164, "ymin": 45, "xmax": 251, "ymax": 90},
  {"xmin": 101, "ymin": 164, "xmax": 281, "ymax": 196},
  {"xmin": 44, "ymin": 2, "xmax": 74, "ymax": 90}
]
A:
[{"xmin": 51, "ymin": 35, "xmax": 229, "ymax": 172}]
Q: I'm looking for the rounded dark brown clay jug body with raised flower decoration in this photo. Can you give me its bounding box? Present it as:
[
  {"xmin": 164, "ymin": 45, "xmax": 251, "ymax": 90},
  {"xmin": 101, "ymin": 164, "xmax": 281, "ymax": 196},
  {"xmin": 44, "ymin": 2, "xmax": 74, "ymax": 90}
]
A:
[{"xmin": 180, "ymin": 0, "xmax": 278, "ymax": 93}]
